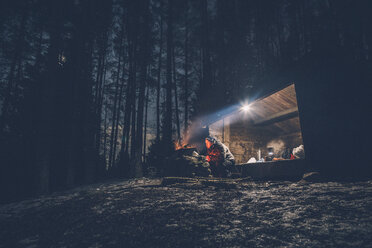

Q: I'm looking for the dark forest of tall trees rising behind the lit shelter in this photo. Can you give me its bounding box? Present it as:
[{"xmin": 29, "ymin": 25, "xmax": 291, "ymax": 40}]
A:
[{"xmin": 0, "ymin": 0, "xmax": 372, "ymax": 201}]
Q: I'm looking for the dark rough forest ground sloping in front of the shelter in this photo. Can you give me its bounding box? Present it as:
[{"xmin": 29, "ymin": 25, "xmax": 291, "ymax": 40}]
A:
[{"xmin": 0, "ymin": 179, "xmax": 372, "ymax": 248}]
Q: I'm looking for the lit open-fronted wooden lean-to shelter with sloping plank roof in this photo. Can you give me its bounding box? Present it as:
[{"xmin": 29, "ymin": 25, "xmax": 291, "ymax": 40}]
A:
[{"xmin": 206, "ymin": 84, "xmax": 306, "ymax": 178}]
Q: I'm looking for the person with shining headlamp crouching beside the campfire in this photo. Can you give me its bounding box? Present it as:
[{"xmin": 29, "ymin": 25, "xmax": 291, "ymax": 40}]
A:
[{"xmin": 205, "ymin": 136, "xmax": 235, "ymax": 177}]
